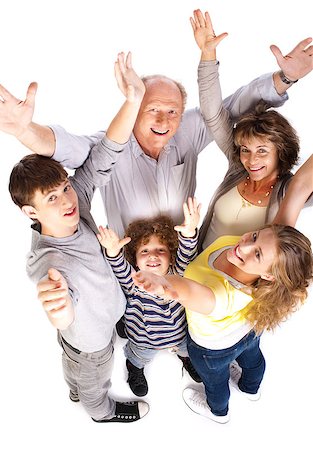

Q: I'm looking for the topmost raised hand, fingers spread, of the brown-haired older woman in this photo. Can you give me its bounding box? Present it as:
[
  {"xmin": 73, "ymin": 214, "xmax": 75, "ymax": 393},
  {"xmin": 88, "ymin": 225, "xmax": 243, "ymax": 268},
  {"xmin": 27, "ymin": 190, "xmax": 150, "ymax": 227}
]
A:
[{"xmin": 190, "ymin": 9, "xmax": 228, "ymax": 59}]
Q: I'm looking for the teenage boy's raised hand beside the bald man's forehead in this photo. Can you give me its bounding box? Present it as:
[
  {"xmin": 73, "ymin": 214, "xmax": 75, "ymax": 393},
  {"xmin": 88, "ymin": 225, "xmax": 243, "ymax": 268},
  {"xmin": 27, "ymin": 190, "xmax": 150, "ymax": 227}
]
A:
[{"xmin": 114, "ymin": 52, "xmax": 146, "ymax": 103}]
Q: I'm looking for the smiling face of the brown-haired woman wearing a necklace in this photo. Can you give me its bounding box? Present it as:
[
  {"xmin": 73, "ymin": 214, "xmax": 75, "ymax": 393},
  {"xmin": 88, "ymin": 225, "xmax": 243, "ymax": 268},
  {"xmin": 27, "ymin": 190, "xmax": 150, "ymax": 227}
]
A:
[{"xmin": 240, "ymin": 138, "xmax": 279, "ymax": 181}]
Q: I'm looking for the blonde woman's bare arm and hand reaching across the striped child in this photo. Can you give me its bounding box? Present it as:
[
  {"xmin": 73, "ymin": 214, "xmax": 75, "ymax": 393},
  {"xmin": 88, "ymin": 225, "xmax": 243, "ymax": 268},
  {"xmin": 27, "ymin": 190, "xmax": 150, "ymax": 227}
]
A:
[{"xmin": 132, "ymin": 271, "xmax": 215, "ymax": 314}]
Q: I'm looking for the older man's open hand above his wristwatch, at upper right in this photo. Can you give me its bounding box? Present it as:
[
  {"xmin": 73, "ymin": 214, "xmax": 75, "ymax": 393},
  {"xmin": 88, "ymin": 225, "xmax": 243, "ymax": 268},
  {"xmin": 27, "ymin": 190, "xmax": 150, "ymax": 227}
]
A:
[{"xmin": 270, "ymin": 38, "xmax": 313, "ymax": 81}]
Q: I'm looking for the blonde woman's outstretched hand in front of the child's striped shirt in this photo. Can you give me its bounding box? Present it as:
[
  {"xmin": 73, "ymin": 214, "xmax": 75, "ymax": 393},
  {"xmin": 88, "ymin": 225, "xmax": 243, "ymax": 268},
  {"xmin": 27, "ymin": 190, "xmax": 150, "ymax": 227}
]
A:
[{"xmin": 132, "ymin": 270, "xmax": 178, "ymax": 301}]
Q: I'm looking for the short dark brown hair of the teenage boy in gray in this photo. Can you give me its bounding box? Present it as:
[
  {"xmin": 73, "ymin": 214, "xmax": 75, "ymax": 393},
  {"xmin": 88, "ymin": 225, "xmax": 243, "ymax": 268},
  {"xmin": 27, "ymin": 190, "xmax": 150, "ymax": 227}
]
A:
[{"xmin": 9, "ymin": 154, "xmax": 68, "ymax": 208}]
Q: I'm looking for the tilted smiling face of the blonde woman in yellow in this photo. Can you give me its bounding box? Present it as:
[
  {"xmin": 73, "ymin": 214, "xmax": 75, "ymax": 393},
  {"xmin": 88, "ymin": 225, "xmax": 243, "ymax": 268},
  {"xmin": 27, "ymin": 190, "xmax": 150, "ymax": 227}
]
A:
[{"xmin": 226, "ymin": 228, "xmax": 277, "ymax": 280}]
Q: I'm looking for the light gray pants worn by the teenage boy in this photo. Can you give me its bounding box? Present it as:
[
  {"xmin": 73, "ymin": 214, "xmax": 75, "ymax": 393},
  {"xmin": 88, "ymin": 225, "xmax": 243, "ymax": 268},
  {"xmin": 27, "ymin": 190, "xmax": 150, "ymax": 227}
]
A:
[{"xmin": 58, "ymin": 333, "xmax": 115, "ymax": 420}]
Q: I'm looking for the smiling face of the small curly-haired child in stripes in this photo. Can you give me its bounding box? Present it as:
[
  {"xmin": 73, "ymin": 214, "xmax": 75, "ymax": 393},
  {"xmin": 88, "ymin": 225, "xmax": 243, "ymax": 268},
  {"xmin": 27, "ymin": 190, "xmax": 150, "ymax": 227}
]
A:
[{"xmin": 136, "ymin": 235, "xmax": 171, "ymax": 275}]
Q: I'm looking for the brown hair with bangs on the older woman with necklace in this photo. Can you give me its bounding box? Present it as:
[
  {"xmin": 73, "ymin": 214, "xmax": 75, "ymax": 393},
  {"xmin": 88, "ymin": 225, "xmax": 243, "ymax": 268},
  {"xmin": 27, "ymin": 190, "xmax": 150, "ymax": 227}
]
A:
[{"xmin": 233, "ymin": 101, "xmax": 300, "ymax": 176}]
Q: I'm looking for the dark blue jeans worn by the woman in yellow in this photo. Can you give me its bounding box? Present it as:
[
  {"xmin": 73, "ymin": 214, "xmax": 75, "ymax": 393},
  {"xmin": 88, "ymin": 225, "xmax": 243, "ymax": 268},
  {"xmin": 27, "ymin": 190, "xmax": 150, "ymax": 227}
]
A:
[{"xmin": 187, "ymin": 331, "xmax": 265, "ymax": 416}]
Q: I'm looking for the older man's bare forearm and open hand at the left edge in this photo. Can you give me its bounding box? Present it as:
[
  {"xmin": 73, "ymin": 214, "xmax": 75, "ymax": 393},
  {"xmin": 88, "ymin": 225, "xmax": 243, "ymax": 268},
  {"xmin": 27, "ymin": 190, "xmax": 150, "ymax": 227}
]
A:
[{"xmin": 0, "ymin": 83, "xmax": 55, "ymax": 156}]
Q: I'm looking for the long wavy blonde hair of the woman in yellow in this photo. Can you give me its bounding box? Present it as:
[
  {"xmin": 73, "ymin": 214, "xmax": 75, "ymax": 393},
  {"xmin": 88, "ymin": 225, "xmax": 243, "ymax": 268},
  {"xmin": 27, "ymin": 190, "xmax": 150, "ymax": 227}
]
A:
[{"xmin": 244, "ymin": 225, "xmax": 313, "ymax": 334}]
